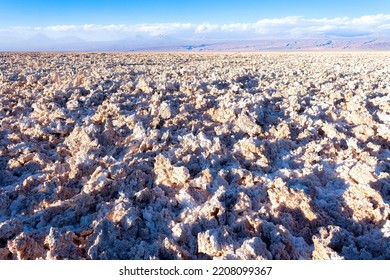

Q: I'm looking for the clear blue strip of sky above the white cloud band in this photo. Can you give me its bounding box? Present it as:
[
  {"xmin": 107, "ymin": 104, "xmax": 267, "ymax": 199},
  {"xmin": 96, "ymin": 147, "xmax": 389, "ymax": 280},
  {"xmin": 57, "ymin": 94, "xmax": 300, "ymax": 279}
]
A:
[{"xmin": 0, "ymin": 0, "xmax": 390, "ymax": 27}]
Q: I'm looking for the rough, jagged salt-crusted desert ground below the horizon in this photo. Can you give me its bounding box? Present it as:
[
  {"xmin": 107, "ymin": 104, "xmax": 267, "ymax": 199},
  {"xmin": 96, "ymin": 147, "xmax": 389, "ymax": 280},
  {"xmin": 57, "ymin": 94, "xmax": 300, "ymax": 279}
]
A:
[{"xmin": 0, "ymin": 52, "xmax": 390, "ymax": 260}]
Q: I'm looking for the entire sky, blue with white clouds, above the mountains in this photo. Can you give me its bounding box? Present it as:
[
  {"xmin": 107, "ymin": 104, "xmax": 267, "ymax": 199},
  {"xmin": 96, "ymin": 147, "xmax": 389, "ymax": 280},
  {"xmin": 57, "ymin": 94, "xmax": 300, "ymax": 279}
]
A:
[{"xmin": 0, "ymin": 0, "xmax": 390, "ymax": 41}]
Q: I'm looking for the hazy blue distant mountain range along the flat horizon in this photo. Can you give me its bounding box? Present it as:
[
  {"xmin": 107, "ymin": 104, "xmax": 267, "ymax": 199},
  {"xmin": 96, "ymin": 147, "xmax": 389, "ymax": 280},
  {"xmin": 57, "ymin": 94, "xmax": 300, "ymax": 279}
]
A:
[{"xmin": 0, "ymin": 33, "xmax": 390, "ymax": 52}]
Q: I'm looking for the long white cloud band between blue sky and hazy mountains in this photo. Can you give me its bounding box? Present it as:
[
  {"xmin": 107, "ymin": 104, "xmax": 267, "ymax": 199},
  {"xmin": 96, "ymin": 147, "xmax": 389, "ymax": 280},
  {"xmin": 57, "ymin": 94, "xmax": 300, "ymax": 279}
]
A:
[{"xmin": 0, "ymin": 14, "xmax": 390, "ymax": 40}]
